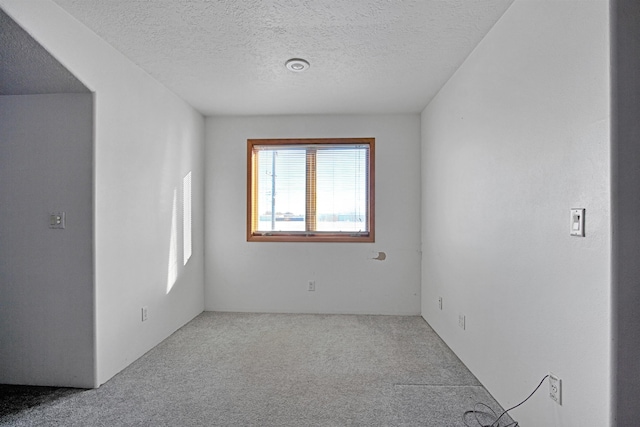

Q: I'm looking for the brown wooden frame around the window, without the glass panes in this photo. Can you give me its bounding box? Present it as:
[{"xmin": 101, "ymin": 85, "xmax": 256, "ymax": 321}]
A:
[{"xmin": 247, "ymin": 138, "xmax": 375, "ymax": 243}]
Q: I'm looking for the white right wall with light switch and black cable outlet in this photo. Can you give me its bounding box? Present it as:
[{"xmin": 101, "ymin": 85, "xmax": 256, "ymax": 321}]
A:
[{"xmin": 422, "ymin": 0, "xmax": 611, "ymax": 426}]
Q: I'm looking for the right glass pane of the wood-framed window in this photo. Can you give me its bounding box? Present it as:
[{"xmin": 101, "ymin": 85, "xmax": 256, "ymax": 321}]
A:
[{"xmin": 316, "ymin": 146, "xmax": 368, "ymax": 232}]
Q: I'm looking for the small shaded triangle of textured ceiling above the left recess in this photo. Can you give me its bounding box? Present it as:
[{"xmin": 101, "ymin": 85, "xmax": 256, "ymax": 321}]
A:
[{"xmin": 0, "ymin": 10, "xmax": 89, "ymax": 95}]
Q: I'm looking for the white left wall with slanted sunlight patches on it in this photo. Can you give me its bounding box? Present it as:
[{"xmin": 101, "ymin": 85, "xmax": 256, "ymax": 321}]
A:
[{"xmin": 0, "ymin": 0, "xmax": 204, "ymax": 385}]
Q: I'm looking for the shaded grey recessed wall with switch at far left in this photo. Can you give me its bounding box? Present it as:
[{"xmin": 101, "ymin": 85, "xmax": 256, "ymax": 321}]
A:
[{"xmin": 0, "ymin": 94, "xmax": 94, "ymax": 387}]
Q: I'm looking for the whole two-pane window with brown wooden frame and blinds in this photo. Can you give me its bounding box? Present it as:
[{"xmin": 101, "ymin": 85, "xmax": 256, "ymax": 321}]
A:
[{"xmin": 247, "ymin": 138, "xmax": 375, "ymax": 242}]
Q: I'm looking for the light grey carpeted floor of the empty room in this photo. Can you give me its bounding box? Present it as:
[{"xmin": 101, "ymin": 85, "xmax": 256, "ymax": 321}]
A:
[{"xmin": 0, "ymin": 312, "xmax": 510, "ymax": 427}]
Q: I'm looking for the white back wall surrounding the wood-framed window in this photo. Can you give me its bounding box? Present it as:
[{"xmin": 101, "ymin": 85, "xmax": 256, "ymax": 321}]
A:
[{"xmin": 205, "ymin": 115, "xmax": 421, "ymax": 314}]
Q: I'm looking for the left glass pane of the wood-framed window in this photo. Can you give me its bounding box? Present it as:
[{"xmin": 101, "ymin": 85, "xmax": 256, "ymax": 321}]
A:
[{"xmin": 256, "ymin": 149, "xmax": 306, "ymax": 232}]
